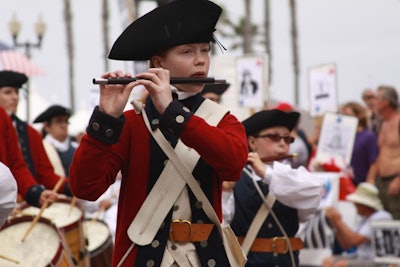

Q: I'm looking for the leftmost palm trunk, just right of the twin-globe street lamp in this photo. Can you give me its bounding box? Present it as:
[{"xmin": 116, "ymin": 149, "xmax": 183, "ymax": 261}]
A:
[{"xmin": 64, "ymin": 0, "xmax": 75, "ymax": 113}]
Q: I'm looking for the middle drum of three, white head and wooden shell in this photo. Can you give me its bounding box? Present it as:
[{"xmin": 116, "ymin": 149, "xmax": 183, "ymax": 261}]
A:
[{"xmin": 22, "ymin": 198, "xmax": 89, "ymax": 267}]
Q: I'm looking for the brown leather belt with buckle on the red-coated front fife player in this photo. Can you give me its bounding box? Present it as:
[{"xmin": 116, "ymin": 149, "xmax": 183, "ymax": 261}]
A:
[{"xmin": 169, "ymin": 220, "xmax": 214, "ymax": 244}]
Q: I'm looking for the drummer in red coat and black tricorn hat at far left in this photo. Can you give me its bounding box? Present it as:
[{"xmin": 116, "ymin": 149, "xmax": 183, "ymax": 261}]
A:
[{"xmin": 0, "ymin": 71, "xmax": 72, "ymax": 202}]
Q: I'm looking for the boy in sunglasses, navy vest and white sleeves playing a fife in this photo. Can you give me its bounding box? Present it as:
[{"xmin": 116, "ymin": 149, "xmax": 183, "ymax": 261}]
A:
[{"xmin": 224, "ymin": 109, "xmax": 322, "ymax": 267}]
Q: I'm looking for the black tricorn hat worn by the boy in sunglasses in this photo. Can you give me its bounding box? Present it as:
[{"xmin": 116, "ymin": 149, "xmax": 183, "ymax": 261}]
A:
[{"xmin": 242, "ymin": 109, "xmax": 300, "ymax": 136}]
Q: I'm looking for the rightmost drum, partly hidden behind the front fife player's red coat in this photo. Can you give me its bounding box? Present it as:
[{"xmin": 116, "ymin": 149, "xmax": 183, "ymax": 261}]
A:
[{"xmin": 83, "ymin": 220, "xmax": 114, "ymax": 267}]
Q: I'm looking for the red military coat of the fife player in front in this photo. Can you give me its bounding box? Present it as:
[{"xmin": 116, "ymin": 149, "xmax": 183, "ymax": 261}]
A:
[{"xmin": 70, "ymin": 100, "xmax": 248, "ymax": 266}]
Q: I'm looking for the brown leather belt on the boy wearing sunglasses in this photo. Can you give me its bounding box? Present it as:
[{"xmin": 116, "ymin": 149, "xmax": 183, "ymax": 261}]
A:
[{"xmin": 237, "ymin": 237, "xmax": 304, "ymax": 254}]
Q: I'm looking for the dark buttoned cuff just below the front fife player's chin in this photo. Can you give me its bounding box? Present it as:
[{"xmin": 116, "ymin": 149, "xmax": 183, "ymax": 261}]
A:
[{"xmin": 160, "ymin": 100, "xmax": 193, "ymax": 137}]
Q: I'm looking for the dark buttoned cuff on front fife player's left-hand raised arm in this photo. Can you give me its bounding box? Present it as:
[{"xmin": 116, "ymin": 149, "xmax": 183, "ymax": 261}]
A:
[{"xmin": 86, "ymin": 106, "xmax": 125, "ymax": 144}]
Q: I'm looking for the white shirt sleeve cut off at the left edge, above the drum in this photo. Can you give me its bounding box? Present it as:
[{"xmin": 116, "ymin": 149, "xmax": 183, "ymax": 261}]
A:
[{"xmin": 0, "ymin": 162, "xmax": 18, "ymax": 229}]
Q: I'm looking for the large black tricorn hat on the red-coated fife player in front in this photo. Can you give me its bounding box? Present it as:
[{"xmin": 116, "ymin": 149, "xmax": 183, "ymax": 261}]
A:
[{"xmin": 108, "ymin": 0, "xmax": 222, "ymax": 60}]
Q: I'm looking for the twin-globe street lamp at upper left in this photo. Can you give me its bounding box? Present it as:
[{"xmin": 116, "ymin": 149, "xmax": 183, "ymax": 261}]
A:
[{"xmin": 9, "ymin": 14, "xmax": 46, "ymax": 122}]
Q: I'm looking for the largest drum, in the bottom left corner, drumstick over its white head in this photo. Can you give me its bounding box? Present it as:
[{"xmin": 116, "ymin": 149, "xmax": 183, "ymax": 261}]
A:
[{"xmin": 0, "ymin": 216, "xmax": 74, "ymax": 267}]
